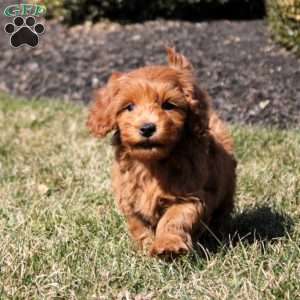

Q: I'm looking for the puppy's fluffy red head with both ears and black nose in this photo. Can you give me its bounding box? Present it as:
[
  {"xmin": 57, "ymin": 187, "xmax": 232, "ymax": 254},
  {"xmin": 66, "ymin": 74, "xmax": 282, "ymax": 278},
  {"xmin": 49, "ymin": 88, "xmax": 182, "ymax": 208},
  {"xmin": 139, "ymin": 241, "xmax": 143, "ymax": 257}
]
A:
[{"xmin": 87, "ymin": 49, "xmax": 208, "ymax": 160}]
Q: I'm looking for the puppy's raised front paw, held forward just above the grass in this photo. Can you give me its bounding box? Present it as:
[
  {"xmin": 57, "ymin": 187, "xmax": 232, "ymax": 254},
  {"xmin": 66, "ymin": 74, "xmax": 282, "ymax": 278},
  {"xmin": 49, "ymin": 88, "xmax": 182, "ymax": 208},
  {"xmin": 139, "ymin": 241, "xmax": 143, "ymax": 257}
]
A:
[{"xmin": 150, "ymin": 234, "xmax": 190, "ymax": 256}]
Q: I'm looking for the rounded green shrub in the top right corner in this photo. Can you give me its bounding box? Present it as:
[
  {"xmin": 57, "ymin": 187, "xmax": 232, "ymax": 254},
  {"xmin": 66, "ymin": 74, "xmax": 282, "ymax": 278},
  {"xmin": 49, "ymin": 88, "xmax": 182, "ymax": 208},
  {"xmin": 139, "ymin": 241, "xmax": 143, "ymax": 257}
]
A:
[{"xmin": 267, "ymin": 0, "xmax": 300, "ymax": 54}]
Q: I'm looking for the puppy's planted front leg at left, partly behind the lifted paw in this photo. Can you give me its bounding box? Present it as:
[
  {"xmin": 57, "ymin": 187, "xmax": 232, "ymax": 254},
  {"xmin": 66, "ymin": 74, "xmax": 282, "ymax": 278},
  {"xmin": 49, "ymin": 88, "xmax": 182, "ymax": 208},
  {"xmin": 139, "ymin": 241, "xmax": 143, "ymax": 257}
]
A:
[{"xmin": 127, "ymin": 215, "xmax": 154, "ymax": 250}]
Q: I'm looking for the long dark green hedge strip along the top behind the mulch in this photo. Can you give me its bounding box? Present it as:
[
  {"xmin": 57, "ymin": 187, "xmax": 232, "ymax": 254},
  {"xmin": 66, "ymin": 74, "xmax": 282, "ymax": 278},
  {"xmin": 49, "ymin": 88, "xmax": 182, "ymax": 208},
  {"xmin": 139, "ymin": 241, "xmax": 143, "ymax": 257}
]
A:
[{"xmin": 39, "ymin": 0, "xmax": 265, "ymax": 24}]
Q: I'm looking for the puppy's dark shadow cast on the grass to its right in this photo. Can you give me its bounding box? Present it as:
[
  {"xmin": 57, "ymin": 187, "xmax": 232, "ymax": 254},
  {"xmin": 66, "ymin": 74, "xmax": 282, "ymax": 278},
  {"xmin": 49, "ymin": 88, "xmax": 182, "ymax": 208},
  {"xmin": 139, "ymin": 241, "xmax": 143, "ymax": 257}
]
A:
[{"xmin": 197, "ymin": 206, "xmax": 293, "ymax": 256}]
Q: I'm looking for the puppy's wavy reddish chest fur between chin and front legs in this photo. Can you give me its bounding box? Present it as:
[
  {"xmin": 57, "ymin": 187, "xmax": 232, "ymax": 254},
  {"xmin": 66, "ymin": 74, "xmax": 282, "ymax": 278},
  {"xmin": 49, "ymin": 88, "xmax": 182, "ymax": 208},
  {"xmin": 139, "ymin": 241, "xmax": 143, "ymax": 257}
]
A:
[{"xmin": 113, "ymin": 159, "xmax": 204, "ymax": 225}]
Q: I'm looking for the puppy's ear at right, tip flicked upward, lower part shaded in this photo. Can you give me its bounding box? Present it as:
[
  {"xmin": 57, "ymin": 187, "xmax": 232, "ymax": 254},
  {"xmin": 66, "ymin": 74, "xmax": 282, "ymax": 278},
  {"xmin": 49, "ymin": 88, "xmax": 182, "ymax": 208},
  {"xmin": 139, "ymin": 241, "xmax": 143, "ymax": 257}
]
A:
[{"xmin": 166, "ymin": 48, "xmax": 210, "ymax": 136}]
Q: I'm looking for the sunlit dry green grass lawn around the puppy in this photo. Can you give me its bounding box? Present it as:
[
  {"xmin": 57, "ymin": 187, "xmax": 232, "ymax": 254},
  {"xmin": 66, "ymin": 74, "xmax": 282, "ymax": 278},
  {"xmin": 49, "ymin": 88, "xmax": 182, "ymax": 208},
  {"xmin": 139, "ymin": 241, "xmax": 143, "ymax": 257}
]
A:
[{"xmin": 0, "ymin": 94, "xmax": 300, "ymax": 300}]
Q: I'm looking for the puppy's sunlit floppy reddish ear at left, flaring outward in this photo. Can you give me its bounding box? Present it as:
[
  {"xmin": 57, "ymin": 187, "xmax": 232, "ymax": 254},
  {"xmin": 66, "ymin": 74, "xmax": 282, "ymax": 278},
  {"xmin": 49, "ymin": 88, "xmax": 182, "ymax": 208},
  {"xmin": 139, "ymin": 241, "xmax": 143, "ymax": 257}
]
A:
[{"xmin": 87, "ymin": 72, "xmax": 122, "ymax": 137}]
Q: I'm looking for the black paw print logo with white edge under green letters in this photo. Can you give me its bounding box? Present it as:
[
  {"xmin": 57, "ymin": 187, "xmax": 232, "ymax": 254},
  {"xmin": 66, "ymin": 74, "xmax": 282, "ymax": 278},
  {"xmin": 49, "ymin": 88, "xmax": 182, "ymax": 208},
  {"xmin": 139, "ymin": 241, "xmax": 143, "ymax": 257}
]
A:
[{"xmin": 4, "ymin": 16, "xmax": 45, "ymax": 48}]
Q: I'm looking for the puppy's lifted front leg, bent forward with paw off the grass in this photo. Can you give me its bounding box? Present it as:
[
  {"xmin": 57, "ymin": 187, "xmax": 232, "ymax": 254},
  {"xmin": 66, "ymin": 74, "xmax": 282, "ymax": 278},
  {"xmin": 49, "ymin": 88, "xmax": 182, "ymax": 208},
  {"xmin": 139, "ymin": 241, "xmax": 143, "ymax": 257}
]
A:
[{"xmin": 150, "ymin": 202, "xmax": 204, "ymax": 256}]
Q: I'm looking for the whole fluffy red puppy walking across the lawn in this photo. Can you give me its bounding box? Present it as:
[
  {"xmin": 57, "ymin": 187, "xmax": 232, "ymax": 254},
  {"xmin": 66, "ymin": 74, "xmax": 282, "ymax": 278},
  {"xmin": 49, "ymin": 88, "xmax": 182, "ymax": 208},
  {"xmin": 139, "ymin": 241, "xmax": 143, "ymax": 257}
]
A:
[{"xmin": 87, "ymin": 48, "xmax": 236, "ymax": 255}]
